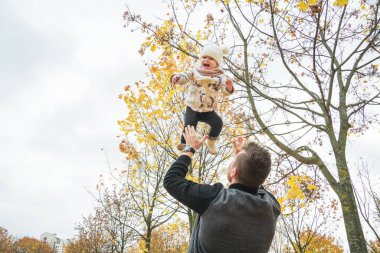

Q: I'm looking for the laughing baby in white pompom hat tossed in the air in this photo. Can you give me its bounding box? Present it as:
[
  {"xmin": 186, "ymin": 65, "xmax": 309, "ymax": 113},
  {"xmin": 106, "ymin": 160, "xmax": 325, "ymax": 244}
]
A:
[{"xmin": 171, "ymin": 45, "xmax": 234, "ymax": 155}]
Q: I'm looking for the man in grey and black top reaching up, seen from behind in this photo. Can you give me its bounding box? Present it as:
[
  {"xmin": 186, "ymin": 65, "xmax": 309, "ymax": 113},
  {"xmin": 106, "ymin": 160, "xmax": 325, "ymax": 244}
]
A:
[{"xmin": 164, "ymin": 126, "xmax": 280, "ymax": 253}]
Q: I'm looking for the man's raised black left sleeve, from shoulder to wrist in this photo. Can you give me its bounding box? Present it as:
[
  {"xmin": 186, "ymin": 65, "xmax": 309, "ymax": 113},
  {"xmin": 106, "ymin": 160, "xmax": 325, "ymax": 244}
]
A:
[{"xmin": 164, "ymin": 155, "xmax": 224, "ymax": 215}]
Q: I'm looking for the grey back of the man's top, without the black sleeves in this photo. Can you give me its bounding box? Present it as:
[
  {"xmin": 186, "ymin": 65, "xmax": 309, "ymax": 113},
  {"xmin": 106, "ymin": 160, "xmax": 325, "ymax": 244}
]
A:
[{"xmin": 189, "ymin": 189, "xmax": 280, "ymax": 253}]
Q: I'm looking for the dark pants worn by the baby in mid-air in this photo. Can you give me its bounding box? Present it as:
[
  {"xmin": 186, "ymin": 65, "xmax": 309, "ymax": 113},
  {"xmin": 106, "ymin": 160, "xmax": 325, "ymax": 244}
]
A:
[{"xmin": 181, "ymin": 106, "xmax": 223, "ymax": 143}]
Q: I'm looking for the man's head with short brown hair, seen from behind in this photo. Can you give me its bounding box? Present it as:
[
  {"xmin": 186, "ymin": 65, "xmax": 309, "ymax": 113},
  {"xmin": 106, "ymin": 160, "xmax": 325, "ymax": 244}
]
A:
[{"xmin": 235, "ymin": 142, "xmax": 271, "ymax": 188}]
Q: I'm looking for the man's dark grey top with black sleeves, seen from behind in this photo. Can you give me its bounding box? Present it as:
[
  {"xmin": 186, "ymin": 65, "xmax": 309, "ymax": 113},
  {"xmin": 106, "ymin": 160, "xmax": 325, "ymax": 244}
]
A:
[{"xmin": 164, "ymin": 155, "xmax": 280, "ymax": 253}]
